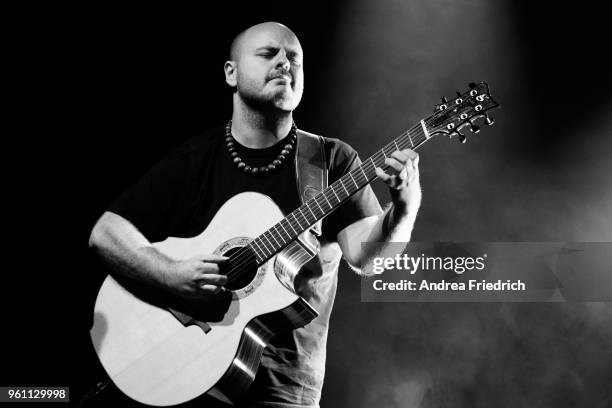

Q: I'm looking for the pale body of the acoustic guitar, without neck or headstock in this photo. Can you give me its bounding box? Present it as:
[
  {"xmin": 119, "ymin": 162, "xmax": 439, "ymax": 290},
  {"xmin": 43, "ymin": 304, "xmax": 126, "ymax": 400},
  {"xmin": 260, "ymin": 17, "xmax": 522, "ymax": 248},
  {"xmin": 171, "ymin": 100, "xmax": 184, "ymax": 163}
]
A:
[{"xmin": 91, "ymin": 192, "xmax": 317, "ymax": 406}]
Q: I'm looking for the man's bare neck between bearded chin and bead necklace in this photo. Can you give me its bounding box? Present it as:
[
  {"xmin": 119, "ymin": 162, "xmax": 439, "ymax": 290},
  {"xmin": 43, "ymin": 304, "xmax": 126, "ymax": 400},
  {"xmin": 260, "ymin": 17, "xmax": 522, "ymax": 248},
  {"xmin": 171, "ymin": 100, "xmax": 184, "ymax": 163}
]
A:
[{"xmin": 232, "ymin": 97, "xmax": 293, "ymax": 149}]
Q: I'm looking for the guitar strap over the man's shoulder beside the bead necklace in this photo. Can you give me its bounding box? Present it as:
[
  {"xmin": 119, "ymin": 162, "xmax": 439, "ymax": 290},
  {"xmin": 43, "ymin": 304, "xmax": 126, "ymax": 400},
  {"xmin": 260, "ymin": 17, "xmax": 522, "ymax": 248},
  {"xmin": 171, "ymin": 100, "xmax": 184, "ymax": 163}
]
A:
[{"xmin": 295, "ymin": 130, "xmax": 327, "ymax": 237}]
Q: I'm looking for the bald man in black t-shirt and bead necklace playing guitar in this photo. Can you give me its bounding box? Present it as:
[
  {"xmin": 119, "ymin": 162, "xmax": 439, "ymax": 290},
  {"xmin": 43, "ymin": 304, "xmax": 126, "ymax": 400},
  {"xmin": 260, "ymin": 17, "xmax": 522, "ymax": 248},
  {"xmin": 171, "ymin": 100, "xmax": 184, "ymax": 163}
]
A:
[{"xmin": 90, "ymin": 22, "xmax": 421, "ymax": 408}]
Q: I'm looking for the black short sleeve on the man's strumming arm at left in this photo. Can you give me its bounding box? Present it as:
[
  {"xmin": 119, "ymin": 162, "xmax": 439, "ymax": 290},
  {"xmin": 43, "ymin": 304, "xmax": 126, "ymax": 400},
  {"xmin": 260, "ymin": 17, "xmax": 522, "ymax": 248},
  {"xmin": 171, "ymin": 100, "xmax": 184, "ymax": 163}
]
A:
[{"xmin": 108, "ymin": 146, "xmax": 191, "ymax": 242}]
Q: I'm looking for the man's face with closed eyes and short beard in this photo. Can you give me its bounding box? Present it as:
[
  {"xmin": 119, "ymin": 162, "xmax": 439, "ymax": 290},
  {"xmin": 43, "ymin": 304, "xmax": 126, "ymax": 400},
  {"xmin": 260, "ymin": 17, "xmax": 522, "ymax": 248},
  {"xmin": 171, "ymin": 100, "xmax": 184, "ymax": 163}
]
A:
[{"xmin": 235, "ymin": 25, "xmax": 304, "ymax": 111}]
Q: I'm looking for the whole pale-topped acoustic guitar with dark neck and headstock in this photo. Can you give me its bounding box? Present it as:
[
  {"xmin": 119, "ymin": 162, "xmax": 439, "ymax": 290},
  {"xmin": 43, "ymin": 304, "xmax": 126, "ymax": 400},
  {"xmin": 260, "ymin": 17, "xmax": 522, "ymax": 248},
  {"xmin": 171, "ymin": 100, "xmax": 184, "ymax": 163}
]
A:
[{"xmin": 91, "ymin": 82, "xmax": 498, "ymax": 406}]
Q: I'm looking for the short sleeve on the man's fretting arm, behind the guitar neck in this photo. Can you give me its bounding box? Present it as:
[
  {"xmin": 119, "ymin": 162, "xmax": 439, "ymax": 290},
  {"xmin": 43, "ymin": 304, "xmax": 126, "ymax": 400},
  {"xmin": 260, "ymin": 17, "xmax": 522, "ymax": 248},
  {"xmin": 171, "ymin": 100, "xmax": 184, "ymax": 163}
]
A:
[{"xmin": 322, "ymin": 138, "xmax": 383, "ymax": 241}]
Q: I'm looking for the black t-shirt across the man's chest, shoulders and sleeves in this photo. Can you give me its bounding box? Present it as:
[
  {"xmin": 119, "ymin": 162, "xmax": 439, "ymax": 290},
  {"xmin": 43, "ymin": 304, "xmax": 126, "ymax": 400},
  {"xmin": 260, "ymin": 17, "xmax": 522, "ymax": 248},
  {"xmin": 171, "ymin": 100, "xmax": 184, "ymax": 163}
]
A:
[{"xmin": 109, "ymin": 128, "xmax": 380, "ymax": 242}]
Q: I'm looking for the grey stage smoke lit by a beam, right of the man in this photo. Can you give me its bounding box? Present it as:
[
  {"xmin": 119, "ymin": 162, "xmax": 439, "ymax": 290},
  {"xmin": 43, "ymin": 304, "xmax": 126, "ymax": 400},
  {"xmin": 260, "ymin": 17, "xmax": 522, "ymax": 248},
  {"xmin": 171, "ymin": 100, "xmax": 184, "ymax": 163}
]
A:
[{"xmin": 319, "ymin": 0, "xmax": 612, "ymax": 408}]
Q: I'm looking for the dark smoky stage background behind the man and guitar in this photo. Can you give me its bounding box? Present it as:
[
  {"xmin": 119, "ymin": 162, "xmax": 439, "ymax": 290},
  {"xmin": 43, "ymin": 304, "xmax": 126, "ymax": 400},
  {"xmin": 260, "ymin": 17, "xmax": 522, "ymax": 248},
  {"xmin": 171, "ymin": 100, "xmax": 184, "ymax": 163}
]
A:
[{"xmin": 0, "ymin": 0, "xmax": 612, "ymax": 408}]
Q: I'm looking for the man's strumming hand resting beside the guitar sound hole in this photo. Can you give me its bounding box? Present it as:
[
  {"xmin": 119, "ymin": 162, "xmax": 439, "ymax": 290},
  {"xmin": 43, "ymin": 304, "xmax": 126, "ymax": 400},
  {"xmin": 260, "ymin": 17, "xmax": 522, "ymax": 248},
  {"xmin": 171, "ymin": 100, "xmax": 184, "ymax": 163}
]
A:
[{"xmin": 164, "ymin": 254, "xmax": 228, "ymax": 299}]
